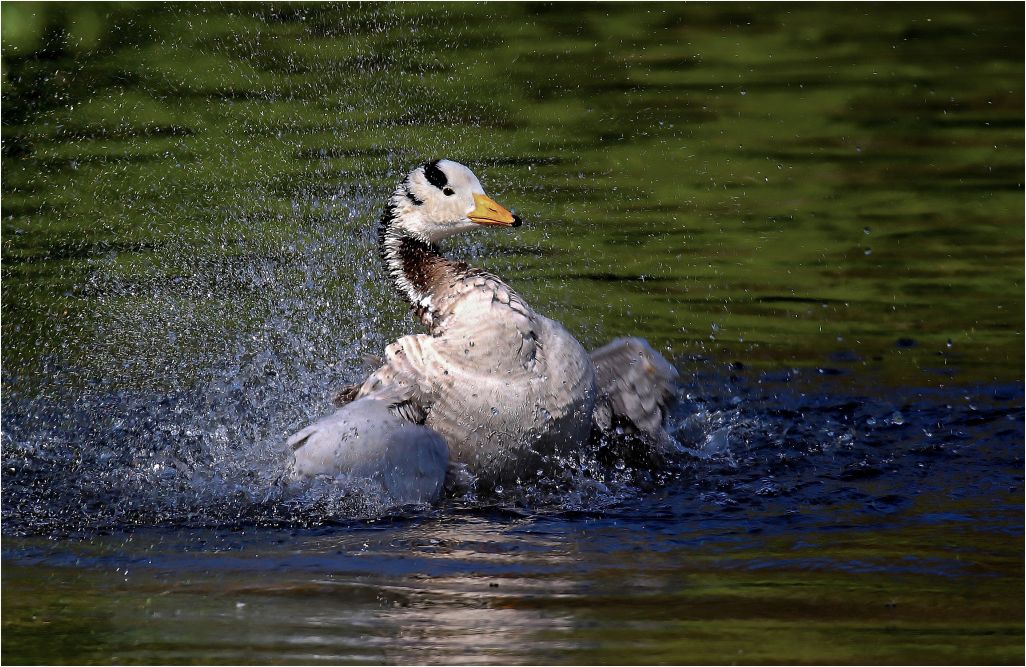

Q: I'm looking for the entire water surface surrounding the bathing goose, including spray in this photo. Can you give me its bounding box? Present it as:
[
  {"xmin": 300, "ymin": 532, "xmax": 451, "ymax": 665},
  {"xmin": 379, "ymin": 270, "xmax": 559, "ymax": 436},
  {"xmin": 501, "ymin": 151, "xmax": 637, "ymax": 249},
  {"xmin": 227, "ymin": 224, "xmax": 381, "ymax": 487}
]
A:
[{"xmin": 2, "ymin": 3, "xmax": 1024, "ymax": 663}]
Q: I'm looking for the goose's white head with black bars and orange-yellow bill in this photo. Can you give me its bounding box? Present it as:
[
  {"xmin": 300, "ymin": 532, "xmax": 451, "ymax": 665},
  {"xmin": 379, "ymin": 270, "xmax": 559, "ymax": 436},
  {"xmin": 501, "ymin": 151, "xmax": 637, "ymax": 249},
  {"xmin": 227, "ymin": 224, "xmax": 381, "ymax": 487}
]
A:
[{"xmin": 387, "ymin": 160, "xmax": 520, "ymax": 243}]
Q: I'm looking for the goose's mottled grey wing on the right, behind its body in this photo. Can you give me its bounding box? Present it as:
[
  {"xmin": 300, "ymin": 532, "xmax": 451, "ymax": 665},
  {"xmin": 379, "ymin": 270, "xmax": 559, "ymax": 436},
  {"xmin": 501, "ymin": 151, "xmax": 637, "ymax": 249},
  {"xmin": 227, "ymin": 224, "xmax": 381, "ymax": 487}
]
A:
[{"xmin": 591, "ymin": 338, "xmax": 677, "ymax": 444}]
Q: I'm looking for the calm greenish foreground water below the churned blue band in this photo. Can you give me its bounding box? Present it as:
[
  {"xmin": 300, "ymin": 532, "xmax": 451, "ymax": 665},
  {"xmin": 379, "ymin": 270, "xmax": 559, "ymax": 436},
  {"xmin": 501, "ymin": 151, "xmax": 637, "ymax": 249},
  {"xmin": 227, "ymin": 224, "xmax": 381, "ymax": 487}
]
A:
[{"xmin": 3, "ymin": 521, "xmax": 1023, "ymax": 664}]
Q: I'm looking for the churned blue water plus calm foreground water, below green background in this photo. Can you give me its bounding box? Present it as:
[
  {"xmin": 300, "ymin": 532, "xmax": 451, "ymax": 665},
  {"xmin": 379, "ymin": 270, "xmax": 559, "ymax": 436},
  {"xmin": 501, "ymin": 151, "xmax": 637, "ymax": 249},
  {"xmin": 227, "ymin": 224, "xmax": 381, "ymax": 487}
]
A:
[{"xmin": 3, "ymin": 352, "xmax": 1023, "ymax": 664}]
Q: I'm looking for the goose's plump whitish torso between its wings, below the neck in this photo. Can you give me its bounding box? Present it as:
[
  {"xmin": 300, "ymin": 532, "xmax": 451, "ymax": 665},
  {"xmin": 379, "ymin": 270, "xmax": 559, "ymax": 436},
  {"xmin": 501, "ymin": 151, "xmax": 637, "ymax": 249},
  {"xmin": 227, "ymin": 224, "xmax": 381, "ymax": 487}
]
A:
[{"xmin": 357, "ymin": 274, "xmax": 596, "ymax": 481}]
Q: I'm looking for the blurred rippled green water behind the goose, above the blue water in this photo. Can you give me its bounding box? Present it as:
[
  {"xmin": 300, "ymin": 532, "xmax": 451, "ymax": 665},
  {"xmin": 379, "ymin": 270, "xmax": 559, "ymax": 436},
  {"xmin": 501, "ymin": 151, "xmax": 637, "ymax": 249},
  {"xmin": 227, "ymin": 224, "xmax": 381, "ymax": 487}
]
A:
[{"xmin": 2, "ymin": 2, "xmax": 1024, "ymax": 385}]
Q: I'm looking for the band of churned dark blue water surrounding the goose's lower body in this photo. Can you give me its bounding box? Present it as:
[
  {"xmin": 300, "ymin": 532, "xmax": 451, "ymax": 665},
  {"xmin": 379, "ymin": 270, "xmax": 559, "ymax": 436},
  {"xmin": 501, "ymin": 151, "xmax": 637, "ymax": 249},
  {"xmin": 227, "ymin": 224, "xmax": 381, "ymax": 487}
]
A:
[{"xmin": 3, "ymin": 352, "xmax": 1023, "ymax": 539}]
